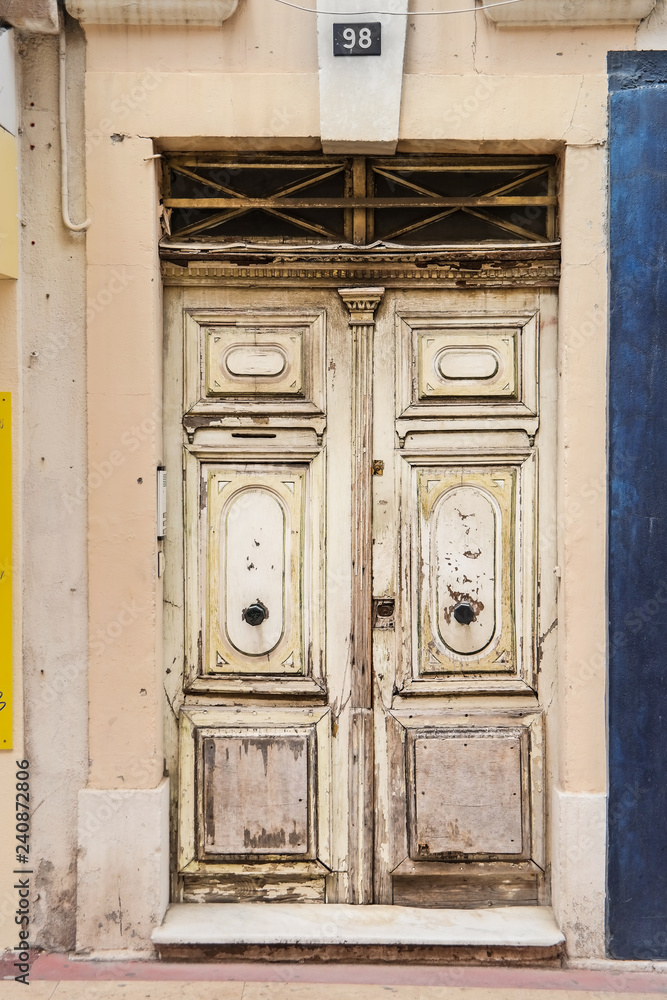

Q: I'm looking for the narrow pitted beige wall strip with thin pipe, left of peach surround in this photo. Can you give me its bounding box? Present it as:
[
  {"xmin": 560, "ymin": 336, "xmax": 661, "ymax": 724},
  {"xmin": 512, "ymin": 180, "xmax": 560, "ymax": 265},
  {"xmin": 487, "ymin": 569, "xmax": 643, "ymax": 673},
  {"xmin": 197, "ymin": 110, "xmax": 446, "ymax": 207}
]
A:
[{"xmin": 18, "ymin": 24, "xmax": 88, "ymax": 949}]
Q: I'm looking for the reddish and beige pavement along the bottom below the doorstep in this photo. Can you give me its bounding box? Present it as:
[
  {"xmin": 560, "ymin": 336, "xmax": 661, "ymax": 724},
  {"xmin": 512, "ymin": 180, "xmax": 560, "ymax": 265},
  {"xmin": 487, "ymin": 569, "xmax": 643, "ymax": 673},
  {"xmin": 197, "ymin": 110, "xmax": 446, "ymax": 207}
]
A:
[{"xmin": 0, "ymin": 954, "xmax": 667, "ymax": 1000}]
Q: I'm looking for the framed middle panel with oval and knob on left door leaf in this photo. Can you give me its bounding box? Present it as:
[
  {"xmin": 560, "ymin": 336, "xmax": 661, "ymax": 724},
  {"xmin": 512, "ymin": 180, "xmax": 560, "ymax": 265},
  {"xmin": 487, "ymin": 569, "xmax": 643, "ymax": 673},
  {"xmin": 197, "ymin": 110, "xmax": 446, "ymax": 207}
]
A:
[{"xmin": 186, "ymin": 454, "xmax": 326, "ymax": 694}]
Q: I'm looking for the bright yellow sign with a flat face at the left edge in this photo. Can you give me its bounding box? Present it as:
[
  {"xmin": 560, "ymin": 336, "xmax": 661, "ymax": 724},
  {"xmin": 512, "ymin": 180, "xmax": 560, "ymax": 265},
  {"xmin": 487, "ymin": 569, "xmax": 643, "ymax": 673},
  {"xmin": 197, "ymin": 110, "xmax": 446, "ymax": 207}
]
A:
[{"xmin": 0, "ymin": 392, "xmax": 12, "ymax": 750}]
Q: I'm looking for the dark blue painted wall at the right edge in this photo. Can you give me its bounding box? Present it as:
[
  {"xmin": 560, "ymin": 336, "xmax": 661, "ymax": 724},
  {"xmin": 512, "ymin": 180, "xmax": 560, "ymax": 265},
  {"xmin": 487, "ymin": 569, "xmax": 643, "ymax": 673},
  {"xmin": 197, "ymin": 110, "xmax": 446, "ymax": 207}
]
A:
[{"xmin": 607, "ymin": 52, "xmax": 667, "ymax": 959}]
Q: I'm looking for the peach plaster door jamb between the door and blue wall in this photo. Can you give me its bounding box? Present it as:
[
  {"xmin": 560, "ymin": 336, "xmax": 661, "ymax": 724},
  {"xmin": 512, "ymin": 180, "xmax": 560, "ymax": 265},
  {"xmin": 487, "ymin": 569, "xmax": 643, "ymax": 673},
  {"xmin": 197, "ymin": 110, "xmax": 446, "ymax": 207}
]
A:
[{"xmin": 558, "ymin": 146, "xmax": 607, "ymax": 792}]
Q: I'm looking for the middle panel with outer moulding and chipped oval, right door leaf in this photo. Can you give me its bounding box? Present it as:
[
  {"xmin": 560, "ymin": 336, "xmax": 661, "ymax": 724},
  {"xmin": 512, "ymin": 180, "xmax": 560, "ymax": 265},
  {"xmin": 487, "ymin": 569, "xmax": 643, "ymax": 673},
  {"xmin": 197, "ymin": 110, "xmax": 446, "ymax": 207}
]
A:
[{"xmin": 401, "ymin": 455, "xmax": 534, "ymax": 693}]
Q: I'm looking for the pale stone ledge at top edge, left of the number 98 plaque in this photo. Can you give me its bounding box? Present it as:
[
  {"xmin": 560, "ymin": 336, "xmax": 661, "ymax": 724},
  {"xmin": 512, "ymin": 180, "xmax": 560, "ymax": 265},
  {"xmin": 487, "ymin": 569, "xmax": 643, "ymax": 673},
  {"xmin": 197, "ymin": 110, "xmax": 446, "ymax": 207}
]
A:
[{"xmin": 65, "ymin": 0, "xmax": 238, "ymax": 27}]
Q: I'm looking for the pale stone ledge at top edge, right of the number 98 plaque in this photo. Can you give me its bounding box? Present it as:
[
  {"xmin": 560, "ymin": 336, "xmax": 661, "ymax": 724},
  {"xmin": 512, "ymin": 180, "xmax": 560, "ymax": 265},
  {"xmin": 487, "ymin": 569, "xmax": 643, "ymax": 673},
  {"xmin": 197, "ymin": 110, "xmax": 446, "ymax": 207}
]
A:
[{"xmin": 482, "ymin": 0, "xmax": 656, "ymax": 28}]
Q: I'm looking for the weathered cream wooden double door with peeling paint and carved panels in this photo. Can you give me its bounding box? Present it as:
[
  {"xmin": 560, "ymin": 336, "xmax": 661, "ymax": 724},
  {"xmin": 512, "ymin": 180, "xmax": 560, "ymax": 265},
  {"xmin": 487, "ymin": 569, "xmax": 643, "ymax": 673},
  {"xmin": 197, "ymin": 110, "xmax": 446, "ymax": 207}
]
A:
[{"xmin": 165, "ymin": 282, "xmax": 556, "ymax": 907}]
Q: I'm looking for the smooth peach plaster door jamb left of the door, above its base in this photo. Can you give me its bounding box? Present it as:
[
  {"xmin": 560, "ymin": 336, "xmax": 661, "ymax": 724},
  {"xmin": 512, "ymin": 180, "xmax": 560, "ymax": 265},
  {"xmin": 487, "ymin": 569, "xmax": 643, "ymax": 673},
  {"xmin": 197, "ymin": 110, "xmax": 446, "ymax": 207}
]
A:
[{"xmin": 87, "ymin": 136, "xmax": 163, "ymax": 788}]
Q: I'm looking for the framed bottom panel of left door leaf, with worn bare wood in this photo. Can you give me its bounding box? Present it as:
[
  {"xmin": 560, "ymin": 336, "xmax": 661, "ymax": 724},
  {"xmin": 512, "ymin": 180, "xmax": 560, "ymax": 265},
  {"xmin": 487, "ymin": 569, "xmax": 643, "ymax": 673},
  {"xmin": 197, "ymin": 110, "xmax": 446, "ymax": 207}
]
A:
[{"xmin": 179, "ymin": 707, "xmax": 331, "ymax": 902}]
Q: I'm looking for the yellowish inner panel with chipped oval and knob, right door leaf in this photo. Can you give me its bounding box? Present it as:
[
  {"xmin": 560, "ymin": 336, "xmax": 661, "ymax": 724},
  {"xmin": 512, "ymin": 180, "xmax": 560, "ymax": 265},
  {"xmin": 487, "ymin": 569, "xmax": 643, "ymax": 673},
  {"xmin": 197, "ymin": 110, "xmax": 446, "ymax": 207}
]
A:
[{"xmin": 412, "ymin": 465, "xmax": 521, "ymax": 674}]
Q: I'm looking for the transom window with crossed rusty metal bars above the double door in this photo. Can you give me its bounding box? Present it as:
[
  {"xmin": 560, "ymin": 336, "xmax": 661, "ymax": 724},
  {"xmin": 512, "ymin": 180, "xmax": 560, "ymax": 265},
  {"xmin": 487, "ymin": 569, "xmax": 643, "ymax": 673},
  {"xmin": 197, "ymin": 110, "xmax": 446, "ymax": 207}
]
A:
[{"xmin": 163, "ymin": 153, "xmax": 557, "ymax": 246}]
